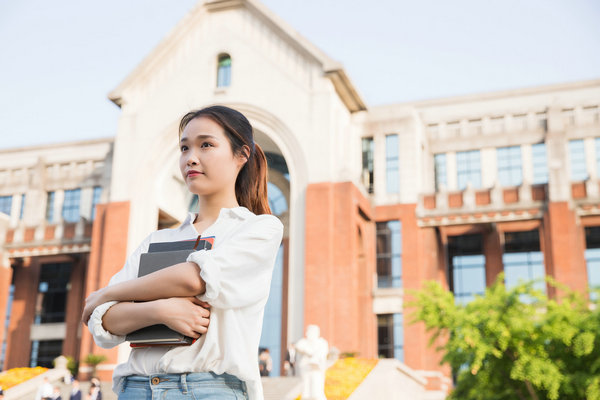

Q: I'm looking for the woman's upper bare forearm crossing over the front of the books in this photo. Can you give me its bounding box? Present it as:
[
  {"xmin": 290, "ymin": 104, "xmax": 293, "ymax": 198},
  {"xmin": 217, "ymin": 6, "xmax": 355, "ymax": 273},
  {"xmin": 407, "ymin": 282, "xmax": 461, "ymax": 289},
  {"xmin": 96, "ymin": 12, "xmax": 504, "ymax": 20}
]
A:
[{"xmin": 81, "ymin": 262, "xmax": 206, "ymax": 324}]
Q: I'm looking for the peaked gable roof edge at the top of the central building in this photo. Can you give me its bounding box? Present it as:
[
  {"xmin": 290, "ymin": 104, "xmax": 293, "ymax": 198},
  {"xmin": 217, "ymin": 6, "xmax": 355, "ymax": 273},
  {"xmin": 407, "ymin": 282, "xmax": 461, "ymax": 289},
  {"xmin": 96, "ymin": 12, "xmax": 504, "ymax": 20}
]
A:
[{"xmin": 108, "ymin": 0, "xmax": 367, "ymax": 112}]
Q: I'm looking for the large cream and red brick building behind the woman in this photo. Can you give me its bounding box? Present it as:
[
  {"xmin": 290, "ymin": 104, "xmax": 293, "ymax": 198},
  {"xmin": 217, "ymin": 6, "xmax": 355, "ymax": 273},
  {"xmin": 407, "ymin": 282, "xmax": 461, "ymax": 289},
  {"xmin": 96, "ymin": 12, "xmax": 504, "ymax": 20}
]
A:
[{"xmin": 0, "ymin": 0, "xmax": 600, "ymax": 394}]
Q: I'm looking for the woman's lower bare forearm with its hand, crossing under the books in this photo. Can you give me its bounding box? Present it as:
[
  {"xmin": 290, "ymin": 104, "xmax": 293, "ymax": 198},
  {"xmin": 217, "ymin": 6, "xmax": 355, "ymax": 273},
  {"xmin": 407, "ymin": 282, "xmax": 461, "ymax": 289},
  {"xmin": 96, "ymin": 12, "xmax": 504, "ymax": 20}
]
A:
[{"xmin": 102, "ymin": 297, "xmax": 210, "ymax": 338}]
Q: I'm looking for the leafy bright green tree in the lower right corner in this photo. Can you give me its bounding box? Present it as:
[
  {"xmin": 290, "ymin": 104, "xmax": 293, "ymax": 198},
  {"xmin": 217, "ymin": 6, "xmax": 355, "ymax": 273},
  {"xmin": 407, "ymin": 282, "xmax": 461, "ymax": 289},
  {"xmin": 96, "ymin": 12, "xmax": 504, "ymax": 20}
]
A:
[{"xmin": 409, "ymin": 275, "xmax": 600, "ymax": 400}]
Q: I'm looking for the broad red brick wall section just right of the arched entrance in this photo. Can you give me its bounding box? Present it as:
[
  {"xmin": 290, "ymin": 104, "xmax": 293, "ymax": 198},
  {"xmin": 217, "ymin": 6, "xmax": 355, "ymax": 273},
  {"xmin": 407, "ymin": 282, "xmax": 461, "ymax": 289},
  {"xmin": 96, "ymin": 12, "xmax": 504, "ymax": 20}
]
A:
[{"xmin": 304, "ymin": 182, "xmax": 377, "ymax": 357}]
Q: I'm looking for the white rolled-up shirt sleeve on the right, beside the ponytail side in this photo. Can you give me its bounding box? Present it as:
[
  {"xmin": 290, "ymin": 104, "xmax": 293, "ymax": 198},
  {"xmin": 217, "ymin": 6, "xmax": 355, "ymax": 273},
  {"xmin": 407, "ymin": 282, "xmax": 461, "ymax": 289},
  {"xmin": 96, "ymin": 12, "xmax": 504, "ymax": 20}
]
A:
[{"xmin": 187, "ymin": 214, "xmax": 283, "ymax": 308}]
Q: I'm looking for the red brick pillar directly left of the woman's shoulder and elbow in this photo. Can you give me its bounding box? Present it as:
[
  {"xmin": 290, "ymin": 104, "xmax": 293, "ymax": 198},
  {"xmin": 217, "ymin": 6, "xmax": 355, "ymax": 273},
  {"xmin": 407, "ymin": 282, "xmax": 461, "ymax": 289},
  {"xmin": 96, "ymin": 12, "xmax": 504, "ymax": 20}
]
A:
[{"xmin": 79, "ymin": 201, "xmax": 130, "ymax": 380}]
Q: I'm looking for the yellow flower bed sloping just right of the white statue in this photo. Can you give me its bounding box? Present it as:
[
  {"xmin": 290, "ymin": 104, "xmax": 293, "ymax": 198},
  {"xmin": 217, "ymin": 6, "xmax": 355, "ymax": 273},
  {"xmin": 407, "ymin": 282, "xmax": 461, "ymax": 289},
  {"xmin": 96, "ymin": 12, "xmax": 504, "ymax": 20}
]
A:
[{"xmin": 296, "ymin": 357, "xmax": 379, "ymax": 400}]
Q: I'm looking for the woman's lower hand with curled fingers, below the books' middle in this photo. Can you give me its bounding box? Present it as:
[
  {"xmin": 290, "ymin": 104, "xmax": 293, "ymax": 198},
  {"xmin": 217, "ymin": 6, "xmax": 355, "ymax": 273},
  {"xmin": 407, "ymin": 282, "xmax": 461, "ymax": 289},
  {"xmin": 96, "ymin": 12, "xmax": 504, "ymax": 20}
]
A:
[{"xmin": 156, "ymin": 297, "xmax": 210, "ymax": 339}]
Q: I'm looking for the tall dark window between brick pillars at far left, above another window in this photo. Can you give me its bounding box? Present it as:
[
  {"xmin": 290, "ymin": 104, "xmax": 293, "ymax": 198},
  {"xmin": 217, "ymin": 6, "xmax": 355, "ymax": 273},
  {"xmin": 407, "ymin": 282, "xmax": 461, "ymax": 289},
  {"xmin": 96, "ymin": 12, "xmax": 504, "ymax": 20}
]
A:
[{"xmin": 34, "ymin": 263, "xmax": 72, "ymax": 324}]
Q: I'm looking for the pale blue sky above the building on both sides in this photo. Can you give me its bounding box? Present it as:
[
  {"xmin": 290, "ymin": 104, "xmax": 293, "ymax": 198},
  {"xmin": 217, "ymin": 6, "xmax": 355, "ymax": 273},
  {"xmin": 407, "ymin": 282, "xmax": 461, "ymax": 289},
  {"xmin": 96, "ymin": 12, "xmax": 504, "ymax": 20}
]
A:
[{"xmin": 0, "ymin": 0, "xmax": 600, "ymax": 149}]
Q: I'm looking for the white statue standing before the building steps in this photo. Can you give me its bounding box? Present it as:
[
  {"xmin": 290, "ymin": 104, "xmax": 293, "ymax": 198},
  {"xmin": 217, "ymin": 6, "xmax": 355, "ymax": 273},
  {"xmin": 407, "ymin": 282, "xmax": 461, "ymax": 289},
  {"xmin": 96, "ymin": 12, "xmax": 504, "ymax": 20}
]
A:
[{"xmin": 296, "ymin": 325, "xmax": 329, "ymax": 400}]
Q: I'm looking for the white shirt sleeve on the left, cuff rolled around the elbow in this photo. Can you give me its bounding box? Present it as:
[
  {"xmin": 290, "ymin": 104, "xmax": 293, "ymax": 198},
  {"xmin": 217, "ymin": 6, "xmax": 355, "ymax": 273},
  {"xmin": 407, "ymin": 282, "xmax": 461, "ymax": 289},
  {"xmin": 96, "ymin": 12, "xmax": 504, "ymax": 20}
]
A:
[{"xmin": 88, "ymin": 234, "xmax": 152, "ymax": 349}]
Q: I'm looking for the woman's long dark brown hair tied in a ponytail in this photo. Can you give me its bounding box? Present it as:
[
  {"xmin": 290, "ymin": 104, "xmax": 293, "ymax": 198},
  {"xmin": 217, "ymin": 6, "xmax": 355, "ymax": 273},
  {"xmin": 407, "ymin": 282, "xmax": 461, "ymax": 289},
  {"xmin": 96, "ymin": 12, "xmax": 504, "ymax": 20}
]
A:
[{"xmin": 179, "ymin": 106, "xmax": 271, "ymax": 215}]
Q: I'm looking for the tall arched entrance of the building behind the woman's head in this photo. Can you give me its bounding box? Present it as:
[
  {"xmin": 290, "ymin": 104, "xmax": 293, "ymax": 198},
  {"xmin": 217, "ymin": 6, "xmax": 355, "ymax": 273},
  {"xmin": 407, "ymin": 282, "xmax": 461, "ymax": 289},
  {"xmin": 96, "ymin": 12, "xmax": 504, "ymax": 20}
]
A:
[{"xmin": 154, "ymin": 104, "xmax": 306, "ymax": 376}]
